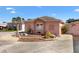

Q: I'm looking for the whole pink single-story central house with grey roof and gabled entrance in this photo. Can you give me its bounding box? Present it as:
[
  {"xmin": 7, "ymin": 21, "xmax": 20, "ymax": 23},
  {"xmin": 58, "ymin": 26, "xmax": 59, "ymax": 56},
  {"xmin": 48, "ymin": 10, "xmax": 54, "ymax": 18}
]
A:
[{"xmin": 25, "ymin": 16, "xmax": 63, "ymax": 36}]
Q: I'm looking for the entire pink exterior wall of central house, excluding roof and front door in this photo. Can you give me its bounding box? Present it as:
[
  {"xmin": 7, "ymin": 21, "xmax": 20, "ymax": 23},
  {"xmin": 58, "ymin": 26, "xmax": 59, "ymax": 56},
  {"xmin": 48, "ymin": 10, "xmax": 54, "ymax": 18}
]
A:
[{"xmin": 25, "ymin": 20, "xmax": 61, "ymax": 36}]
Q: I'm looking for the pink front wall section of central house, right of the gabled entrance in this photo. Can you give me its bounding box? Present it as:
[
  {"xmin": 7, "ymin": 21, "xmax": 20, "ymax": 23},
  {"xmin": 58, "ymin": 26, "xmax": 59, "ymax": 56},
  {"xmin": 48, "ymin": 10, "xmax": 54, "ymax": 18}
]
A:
[{"xmin": 46, "ymin": 21, "xmax": 61, "ymax": 36}]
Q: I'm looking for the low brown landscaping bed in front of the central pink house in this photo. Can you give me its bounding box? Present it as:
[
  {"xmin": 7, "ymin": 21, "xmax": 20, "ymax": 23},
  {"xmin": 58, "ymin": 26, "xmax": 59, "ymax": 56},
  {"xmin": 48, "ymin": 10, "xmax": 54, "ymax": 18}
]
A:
[{"xmin": 19, "ymin": 35, "xmax": 54, "ymax": 42}]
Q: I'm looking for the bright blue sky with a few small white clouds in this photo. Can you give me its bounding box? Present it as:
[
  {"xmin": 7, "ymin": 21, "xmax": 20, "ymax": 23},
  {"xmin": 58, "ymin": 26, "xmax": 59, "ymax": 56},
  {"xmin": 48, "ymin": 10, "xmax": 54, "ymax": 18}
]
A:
[{"xmin": 0, "ymin": 6, "xmax": 79, "ymax": 23}]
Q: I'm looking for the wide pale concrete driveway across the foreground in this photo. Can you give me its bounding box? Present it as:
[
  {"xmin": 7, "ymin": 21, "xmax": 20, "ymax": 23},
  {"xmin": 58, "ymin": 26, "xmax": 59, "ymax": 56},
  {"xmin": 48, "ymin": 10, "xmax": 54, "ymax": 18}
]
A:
[{"xmin": 0, "ymin": 32, "xmax": 73, "ymax": 53}]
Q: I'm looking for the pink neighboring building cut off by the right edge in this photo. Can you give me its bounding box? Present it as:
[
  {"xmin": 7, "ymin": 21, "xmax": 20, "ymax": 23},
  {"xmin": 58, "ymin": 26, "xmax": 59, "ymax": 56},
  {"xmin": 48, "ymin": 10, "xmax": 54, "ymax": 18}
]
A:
[{"xmin": 67, "ymin": 21, "xmax": 79, "ymax": 36}]
